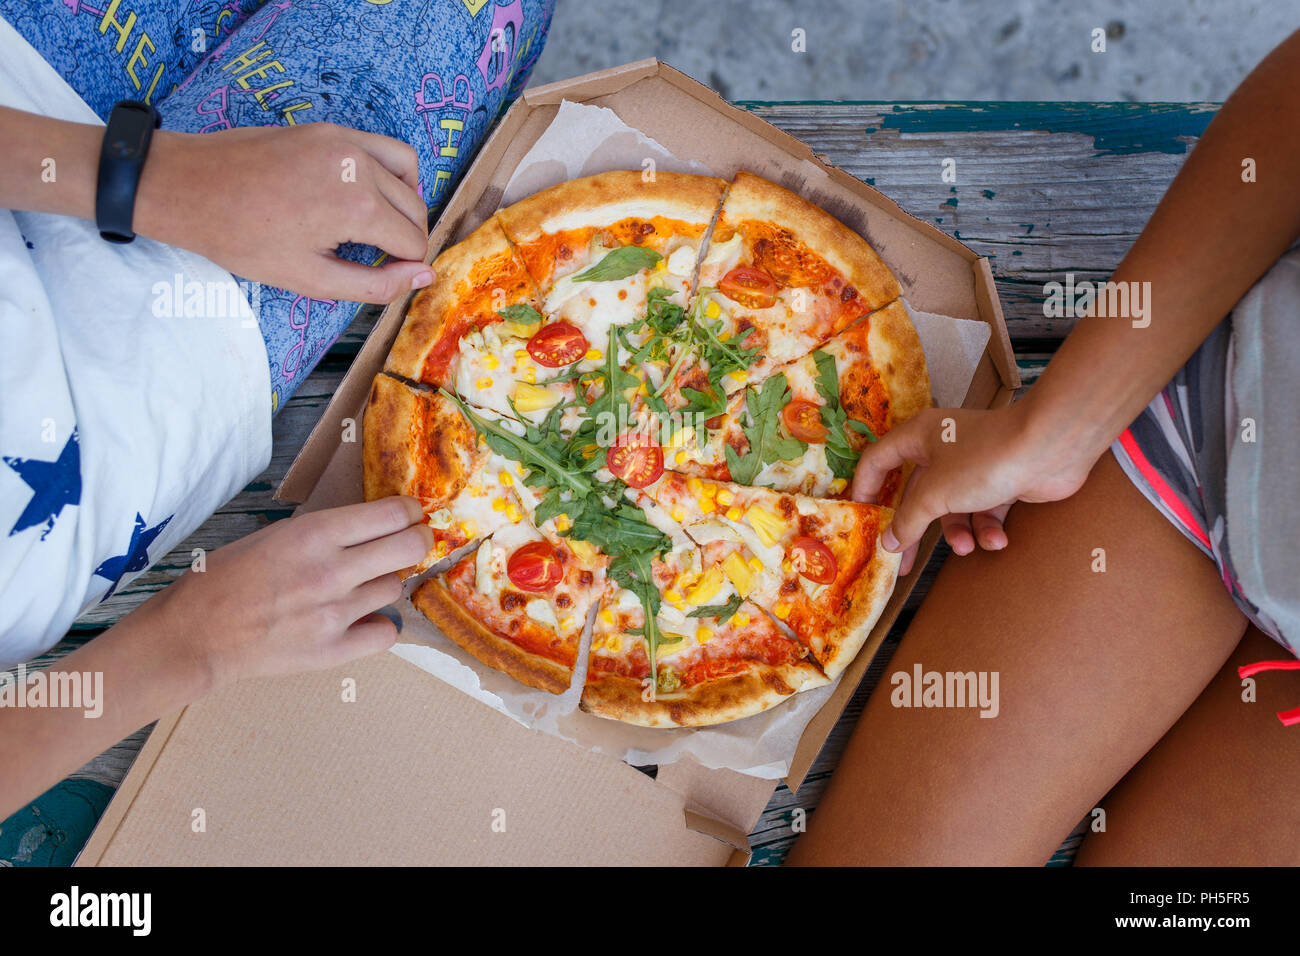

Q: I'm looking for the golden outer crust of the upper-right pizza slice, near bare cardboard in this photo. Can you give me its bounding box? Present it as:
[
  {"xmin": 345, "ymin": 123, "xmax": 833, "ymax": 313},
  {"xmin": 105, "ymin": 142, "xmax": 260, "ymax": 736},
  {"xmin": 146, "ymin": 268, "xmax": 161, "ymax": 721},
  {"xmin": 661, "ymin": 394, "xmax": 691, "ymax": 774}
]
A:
[{"xmin": 719, "ymin": 170, "xmax": 902, "ymax": 310}]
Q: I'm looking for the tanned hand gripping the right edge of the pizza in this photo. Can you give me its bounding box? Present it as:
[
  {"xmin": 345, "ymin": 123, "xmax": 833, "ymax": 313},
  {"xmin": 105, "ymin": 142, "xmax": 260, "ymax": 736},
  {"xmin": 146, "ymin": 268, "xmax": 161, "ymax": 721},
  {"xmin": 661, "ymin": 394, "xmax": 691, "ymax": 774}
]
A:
[{"xmin": 853, "ymin": 403, "xmax": 1096, "ymax": 575}]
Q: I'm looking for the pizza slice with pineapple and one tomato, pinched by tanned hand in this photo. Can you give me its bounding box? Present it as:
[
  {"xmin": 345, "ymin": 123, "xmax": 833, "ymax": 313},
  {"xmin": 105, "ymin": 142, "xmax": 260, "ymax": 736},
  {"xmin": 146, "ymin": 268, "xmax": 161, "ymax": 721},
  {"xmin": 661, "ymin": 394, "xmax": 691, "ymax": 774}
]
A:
[{"xmin": 634, "ymin": 472, "xmax": 900, "ymax": 678}]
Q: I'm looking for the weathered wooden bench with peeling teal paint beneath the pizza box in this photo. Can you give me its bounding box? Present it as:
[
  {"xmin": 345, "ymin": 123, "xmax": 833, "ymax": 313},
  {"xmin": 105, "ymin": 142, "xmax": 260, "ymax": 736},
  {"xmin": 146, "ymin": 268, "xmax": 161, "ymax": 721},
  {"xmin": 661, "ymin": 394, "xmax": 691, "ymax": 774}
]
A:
[{"xmin": 39, "ymin": 103, "xmax": 1217, "ymax": 865}]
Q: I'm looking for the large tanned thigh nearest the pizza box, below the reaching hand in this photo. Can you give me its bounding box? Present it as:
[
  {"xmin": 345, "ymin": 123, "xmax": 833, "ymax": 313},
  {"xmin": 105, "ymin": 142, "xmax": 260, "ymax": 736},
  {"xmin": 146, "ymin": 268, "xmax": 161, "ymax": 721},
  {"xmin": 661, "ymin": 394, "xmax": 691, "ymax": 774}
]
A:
[{"xmin": 789, "ymin": 453, "xmax": 1245, "ymax": 865}]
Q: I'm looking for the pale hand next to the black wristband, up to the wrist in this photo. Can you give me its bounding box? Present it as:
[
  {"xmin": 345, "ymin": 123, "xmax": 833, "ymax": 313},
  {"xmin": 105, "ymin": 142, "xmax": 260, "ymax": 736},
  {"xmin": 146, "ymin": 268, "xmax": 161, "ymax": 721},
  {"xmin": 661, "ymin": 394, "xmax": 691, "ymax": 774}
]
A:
[{"xmin": 134, "ymin": 122, "xmax": 433, "ymax": 302}]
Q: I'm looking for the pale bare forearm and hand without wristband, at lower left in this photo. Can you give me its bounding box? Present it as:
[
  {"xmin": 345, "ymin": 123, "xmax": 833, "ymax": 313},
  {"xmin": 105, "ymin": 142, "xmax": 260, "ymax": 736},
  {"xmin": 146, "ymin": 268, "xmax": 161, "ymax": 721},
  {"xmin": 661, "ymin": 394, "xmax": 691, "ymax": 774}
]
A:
[{"xmin": 0, "ymin": 498, "xmax": 433, "ymax": 819}]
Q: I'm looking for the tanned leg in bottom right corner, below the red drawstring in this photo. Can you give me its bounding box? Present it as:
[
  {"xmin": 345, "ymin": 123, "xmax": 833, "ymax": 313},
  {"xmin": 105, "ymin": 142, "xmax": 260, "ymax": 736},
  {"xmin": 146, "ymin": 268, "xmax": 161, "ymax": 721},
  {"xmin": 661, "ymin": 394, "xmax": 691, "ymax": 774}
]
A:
[{"xmin": 1075, "ymin": 627, "xmax": 1300, "ymax": 866}]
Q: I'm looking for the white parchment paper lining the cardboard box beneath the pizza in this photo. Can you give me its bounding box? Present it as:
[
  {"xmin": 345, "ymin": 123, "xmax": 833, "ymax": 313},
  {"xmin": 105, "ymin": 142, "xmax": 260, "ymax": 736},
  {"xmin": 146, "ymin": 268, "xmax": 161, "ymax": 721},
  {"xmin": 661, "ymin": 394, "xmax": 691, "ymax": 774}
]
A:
[{"xmin": 393, "ymin": 100, "xmax": 989, "ymax": 779}]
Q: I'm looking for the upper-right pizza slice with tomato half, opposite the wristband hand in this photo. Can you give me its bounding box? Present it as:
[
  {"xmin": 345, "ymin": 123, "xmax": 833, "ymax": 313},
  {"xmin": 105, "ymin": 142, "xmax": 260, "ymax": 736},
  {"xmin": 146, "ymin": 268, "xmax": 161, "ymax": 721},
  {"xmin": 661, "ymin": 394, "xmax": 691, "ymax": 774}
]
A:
[{"xmin": 696, "ymin": 172, "xmax": 900, "ymax": 393}]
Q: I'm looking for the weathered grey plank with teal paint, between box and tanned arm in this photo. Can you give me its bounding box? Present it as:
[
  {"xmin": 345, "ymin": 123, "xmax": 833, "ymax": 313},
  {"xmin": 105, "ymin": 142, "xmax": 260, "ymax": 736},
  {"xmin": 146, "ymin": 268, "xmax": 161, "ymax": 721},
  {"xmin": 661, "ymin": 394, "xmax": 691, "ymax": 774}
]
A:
[{"xmin": 748, "ymin": 103, "xmax": 1217, "ymax": 342}]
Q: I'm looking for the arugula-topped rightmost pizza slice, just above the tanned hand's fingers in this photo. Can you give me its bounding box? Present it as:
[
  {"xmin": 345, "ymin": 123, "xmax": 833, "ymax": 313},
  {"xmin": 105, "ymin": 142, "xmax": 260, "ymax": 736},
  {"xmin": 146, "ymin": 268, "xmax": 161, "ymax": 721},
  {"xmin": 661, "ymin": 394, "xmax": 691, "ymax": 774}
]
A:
[{"xmin": 667, "ymin": 299, "xmax": 930, "ymax": 507}]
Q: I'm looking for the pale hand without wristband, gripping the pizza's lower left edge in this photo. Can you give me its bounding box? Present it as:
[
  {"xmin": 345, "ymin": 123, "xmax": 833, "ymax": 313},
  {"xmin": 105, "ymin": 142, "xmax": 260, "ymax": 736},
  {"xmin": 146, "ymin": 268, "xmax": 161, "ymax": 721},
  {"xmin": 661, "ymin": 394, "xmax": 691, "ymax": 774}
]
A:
[{"xmin": 156, "ymin": 498, "xmax": 433, "ymax": 687}]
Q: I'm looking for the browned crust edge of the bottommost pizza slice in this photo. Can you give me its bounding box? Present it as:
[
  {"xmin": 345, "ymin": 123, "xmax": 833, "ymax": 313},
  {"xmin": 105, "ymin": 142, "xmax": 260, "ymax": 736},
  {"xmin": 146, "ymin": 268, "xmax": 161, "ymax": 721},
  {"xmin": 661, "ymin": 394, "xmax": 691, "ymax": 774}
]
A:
[{"xmin": 579, "ymin": 662, "xmax": 828, "ymax": 727}]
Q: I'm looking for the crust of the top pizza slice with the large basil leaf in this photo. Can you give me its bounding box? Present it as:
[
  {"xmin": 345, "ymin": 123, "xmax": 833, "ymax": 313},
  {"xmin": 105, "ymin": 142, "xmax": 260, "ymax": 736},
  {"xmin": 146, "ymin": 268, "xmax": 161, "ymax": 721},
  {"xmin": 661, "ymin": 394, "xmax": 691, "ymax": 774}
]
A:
[{"xmin": 497, "ymin": 169, "xmax": 727, "ymax": 245}]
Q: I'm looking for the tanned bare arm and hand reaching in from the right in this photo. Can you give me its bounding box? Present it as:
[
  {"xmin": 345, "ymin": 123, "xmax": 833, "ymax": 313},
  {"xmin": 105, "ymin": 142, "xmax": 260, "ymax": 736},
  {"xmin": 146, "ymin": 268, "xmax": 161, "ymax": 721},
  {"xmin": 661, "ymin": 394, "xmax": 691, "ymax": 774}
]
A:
[{"xmin": 853, "ymin": 33, "xmax": 1300, "ymax": 571}]
